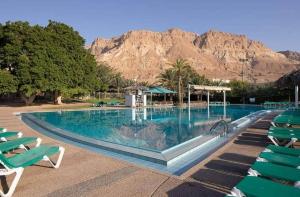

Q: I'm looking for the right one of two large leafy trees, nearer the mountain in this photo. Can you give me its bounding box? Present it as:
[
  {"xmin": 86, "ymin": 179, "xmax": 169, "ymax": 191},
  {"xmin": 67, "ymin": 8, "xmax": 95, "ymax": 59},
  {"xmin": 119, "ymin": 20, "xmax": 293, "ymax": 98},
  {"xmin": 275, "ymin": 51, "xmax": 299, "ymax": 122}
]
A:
[{"xmin": 45, "ymin": 21, "xmax": 99, "ymax": 103}]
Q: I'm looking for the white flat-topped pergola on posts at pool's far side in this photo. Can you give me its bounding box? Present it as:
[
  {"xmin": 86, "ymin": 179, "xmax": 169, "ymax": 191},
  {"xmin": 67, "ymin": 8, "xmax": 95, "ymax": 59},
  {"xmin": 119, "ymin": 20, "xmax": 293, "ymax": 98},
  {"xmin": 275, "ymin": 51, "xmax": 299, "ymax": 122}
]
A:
[{"xmin": 188, "ymin": 84, "xmax": 231, "ymax": 107}]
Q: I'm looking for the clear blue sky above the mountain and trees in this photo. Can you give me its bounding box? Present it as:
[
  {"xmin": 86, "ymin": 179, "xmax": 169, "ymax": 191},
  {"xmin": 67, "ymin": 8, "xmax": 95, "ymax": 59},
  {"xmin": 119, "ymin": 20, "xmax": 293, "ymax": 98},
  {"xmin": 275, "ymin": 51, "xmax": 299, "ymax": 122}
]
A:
[{"xmin": 0, "ymin": 0, "xmax": 300, "ymax": 51}]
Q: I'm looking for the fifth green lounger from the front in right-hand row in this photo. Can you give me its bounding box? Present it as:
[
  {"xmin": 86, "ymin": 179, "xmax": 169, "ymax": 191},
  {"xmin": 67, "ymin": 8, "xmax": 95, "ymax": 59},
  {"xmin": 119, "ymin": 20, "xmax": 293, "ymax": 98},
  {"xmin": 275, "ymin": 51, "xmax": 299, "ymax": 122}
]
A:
[{"xmin": 268, "ymin": 131, "xmax": 300, "ymax": 147}]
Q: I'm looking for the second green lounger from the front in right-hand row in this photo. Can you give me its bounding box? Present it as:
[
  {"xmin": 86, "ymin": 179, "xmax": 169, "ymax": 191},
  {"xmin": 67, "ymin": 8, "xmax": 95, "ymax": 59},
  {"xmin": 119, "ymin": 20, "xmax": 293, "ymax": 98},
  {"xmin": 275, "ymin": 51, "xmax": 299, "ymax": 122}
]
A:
[{"xmin": 248, "ymin": 162, "xmax": 300, "ymax": 187}]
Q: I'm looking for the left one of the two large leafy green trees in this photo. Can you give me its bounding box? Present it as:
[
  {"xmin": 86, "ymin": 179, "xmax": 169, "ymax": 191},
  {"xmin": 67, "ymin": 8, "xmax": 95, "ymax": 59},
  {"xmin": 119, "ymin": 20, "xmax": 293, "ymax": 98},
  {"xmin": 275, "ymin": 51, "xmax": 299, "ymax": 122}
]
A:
[{"xmin": 0, "ymin": 22, "xmax": 45, "ymax": 104}]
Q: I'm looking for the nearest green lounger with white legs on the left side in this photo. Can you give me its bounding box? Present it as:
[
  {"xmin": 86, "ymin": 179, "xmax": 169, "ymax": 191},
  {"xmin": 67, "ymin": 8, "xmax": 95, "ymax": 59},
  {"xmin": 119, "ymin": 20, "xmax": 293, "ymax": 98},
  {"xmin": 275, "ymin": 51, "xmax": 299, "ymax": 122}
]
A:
[{"xmin": 0, "ymin": 145, "xmax": 65, "ymax": 197}]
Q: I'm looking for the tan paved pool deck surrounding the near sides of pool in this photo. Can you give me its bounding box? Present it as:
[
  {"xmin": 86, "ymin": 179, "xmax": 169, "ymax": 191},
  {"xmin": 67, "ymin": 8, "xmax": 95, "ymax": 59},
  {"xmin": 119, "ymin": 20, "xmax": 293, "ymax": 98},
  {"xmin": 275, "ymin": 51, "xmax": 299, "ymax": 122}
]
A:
[{"xmin": 0, "ymin": 106, "xmax": 288, "ymax": 197}]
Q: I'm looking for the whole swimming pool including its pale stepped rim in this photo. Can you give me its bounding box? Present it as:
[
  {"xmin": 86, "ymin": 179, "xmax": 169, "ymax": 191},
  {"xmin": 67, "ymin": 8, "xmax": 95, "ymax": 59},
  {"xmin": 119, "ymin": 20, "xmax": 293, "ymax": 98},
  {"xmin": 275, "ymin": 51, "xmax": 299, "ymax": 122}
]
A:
[{"xmin": 22, "ymin": 105, "xmax": 263, "ymax": 174}]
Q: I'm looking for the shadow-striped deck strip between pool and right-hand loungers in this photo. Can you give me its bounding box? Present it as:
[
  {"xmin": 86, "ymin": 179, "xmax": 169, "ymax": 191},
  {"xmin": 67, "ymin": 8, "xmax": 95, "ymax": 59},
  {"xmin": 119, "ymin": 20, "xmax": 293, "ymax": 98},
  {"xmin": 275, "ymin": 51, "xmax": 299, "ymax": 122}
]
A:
[{"xmin": 167, "ymin": 113, "xmax": 277, "ymax": 197}]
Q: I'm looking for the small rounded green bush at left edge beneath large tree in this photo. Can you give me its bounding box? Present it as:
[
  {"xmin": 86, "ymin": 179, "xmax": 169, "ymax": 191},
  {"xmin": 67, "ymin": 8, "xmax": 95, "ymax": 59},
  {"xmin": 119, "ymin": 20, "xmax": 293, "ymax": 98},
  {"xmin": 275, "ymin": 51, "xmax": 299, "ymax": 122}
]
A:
[{"xmin": 0, "ymin": 70, "xmax": 18, "ymax": 95}]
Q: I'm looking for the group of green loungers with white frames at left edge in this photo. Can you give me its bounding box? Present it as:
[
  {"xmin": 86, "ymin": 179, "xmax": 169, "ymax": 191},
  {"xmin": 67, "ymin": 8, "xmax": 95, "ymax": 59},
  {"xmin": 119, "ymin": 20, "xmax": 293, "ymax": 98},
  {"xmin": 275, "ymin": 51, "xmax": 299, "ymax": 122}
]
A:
[{"xmin": 0, "ymin": 128, "xmax": 65, "ymax": 197}]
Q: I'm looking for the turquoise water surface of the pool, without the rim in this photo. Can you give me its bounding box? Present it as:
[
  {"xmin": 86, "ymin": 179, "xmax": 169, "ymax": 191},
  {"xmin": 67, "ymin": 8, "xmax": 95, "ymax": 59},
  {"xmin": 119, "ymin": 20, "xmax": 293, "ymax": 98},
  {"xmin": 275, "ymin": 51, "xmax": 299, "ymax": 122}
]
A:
[{"xmin": 31, "ymin": 105, "xmax": 263, "ymax": 152}]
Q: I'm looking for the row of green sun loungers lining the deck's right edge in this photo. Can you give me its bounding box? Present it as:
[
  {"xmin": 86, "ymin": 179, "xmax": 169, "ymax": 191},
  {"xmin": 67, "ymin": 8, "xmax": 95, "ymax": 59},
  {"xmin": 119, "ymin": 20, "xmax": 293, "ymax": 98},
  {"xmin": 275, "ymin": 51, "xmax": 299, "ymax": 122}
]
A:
[{"xmin": 227, "ymin": 109, "xmax": 300, "ymax": 197}]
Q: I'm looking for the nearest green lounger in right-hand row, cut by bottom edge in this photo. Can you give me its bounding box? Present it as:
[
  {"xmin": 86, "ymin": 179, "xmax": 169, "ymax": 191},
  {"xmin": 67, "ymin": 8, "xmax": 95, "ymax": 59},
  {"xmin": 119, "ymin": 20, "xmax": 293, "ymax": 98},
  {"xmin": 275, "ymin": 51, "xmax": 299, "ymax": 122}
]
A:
[{"xmin": 229, "ymin": 176, "xmax": 300, "ymax": 197}]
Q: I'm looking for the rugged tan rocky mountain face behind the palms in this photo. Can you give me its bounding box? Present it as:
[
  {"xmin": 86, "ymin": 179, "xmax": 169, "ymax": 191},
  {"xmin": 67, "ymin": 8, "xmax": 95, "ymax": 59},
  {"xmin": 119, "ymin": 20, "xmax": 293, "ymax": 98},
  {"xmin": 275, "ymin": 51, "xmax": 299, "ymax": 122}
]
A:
[{"xmin": 89, "ymin": 29, "xmax": 300, "ymax": 82}]
